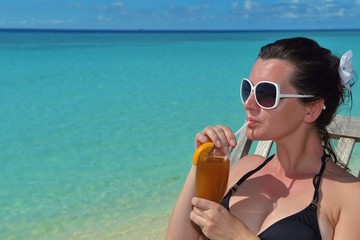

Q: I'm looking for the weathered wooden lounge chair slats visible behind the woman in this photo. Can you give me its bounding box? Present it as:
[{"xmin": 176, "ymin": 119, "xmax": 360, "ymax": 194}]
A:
[{"xmin": 232, "ymin": 115, "xmax": 360, "ymax": 177}]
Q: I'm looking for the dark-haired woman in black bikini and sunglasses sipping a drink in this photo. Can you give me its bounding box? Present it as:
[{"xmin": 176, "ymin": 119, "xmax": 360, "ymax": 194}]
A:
[{"xmin": 166, "ymin": 38, "xmax": 360, "ymax": 240}]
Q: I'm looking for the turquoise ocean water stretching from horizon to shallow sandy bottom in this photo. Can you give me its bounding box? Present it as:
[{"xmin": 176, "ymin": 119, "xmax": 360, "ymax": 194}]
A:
[{"xmin": 0, "ymin": 31, "xmax": 360, "ymax": 240}]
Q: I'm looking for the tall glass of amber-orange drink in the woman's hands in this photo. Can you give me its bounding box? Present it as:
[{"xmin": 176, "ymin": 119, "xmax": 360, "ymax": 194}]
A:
[{"xmin": 195, "ymin": 148, "xmax": 230, "ymax": 203}]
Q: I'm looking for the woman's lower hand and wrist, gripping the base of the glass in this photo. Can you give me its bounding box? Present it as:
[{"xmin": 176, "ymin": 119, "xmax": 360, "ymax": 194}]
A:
[{"xmin": 190, "ymin": 197, "xmax": 259, "ymax": 240}]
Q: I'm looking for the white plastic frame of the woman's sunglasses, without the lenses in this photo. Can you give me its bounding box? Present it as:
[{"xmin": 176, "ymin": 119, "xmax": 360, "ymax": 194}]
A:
[{"xmin": 240, "ymin": 78, "xmax": 315, "ymax": 110}]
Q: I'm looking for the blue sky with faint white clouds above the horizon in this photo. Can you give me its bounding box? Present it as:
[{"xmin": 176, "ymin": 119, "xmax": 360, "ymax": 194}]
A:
[{"xmin": 0, "ymin": 0, "xmax": 360, "ymax": 30}]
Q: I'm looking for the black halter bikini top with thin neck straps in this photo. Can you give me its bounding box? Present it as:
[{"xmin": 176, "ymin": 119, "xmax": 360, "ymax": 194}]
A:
[{"xmin": 221, "ymin": 153, "xmax": 329, "ymax": 240}]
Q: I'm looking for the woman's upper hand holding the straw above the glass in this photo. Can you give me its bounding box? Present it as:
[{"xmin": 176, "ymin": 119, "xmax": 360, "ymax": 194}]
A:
[{"xmin": 195, "ymin": 125, "xmax": 236, "ymax": 154}]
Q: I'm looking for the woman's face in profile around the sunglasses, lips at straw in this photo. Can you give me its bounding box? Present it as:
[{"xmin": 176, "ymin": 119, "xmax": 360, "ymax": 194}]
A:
[{"xmin": 244, "ymin": 59, "xmax": 305, "ymax": 141}]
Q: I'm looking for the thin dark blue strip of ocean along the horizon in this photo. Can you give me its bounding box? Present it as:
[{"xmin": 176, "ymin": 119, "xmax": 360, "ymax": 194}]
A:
[{"xmin": 0, "ymin": 28, "xmax": 360, "ymax": 33}]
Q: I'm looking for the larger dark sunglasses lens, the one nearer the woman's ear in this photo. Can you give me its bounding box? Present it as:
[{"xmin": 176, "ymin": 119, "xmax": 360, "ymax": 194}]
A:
[{"xmin": 255, "ymin": 83, "xmax": 276, "ymax": 108}]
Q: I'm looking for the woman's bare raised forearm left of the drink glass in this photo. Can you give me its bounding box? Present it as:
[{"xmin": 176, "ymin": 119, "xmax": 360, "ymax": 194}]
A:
[{"xmin": 166, "ymin": 166, "xmax": 201, "ymax": 240}]
